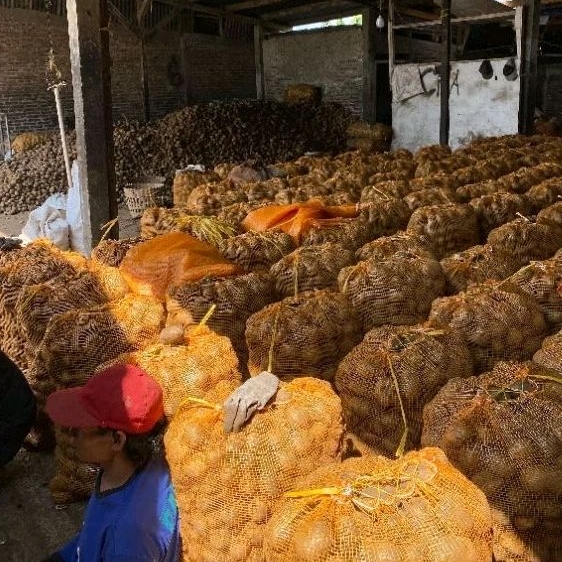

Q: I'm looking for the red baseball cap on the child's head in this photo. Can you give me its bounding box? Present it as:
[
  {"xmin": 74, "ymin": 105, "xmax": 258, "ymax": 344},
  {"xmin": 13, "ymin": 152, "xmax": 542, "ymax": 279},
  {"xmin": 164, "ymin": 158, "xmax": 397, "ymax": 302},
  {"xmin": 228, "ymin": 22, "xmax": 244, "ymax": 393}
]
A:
[{"xmin": 45, "ymin": 364, "xmax": 164, "ymax": 434}]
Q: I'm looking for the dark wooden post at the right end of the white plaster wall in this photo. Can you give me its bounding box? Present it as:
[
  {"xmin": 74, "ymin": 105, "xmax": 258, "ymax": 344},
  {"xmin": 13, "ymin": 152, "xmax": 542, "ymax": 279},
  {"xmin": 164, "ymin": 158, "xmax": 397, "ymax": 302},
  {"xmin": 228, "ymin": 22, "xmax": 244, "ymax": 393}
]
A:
[{"xmin": 519, "ymin": 0, "xmax": 541, "ymax": 135}]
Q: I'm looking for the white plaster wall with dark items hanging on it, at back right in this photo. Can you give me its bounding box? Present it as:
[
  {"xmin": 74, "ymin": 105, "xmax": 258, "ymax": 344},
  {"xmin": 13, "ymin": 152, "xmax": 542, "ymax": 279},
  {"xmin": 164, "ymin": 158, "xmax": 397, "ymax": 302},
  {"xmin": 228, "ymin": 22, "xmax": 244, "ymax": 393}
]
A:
[{"xmin": 392, "ymin": 59, "xmax": 520, "ymax": 151}]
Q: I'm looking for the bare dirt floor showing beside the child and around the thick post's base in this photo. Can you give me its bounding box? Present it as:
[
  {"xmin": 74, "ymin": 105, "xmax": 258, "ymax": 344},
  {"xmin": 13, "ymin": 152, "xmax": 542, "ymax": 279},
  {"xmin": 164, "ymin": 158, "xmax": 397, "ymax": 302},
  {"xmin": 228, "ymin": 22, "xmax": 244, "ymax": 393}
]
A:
[{"xmin": 0, "ymin": 201, "xmax": 140, "ymax": 562}]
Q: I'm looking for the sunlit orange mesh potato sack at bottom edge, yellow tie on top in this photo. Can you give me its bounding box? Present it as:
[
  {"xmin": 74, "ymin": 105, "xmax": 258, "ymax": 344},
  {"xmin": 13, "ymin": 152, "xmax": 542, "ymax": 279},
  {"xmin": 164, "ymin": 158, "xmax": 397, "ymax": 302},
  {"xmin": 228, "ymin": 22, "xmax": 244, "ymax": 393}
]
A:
[{"xmin": 264, "ymin": 448, "xmax": 492, "ymax": 562}]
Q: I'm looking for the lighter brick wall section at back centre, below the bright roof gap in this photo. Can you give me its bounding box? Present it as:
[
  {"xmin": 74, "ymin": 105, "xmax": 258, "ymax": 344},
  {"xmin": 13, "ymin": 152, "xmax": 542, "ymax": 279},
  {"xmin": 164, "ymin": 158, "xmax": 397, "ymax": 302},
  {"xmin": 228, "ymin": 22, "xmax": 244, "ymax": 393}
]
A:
[{"xmin": 263, "ymin": 27, "xmax": 363, "ymax": 113}]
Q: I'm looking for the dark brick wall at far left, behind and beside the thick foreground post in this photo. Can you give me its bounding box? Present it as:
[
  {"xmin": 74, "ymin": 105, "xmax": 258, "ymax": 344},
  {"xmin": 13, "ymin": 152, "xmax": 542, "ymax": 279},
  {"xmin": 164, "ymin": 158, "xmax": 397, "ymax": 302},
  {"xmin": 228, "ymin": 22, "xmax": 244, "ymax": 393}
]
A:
[{"xmin": 0, "ymin": 8, "xmax": 184, "ymax": 136}]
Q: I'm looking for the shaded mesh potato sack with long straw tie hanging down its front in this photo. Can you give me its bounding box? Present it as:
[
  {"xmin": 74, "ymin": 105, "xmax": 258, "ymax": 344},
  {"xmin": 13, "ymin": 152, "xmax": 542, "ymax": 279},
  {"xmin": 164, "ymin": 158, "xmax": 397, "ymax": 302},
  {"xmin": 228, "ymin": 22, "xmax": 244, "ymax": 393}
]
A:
[{"xmin": 335, "ymin": 325, "xmax": 472, "ymax": 457}]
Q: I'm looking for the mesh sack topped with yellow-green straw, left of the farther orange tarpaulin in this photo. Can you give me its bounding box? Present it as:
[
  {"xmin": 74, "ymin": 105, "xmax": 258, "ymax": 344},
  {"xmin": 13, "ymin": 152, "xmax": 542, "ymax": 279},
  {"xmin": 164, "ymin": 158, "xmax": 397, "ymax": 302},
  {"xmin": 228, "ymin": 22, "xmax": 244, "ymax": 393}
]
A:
[{"xmin": 141, "ymin": 207, "xmax": 238, "ymax": 241}]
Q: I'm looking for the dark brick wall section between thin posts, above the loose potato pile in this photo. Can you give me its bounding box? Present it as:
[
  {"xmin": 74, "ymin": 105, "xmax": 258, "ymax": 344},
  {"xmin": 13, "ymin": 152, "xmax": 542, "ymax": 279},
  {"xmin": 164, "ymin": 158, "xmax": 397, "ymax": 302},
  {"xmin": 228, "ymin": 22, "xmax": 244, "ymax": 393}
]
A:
[{"xmin": 182, "ymin": 33, "xmax": 256, "ymax": 103}]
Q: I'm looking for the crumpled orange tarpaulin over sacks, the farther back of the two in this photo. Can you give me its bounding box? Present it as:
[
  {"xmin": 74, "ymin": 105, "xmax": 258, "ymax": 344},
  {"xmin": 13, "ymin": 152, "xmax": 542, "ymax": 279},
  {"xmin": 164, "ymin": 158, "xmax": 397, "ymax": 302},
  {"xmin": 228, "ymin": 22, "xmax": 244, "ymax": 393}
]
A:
[{"xmin": 242, "ymin": 201, "xmax": 359, "ymax": 244}]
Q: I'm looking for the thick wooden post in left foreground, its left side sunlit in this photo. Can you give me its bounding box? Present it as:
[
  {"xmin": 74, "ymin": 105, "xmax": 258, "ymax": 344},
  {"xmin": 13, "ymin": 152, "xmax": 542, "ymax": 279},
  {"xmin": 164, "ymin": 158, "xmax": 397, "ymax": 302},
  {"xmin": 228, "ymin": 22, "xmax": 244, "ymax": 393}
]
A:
[{"xmin": 66, "ymin": 0, "xmax": 119, "ymax": 254}]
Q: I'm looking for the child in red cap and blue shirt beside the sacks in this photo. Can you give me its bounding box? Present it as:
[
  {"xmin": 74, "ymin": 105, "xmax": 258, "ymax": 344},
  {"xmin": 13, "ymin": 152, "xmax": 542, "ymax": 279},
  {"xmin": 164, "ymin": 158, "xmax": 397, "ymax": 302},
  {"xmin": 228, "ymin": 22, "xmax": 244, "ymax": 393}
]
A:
[{"xmin": 45, "ymin": 365, "xmax": 181, "ymax": 562}]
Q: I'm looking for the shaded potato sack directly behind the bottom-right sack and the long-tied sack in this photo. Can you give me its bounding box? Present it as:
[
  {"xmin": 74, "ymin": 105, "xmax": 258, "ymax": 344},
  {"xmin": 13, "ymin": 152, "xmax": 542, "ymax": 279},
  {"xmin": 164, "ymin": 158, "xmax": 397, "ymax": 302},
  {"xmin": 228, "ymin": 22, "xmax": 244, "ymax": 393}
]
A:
[{"xmin": 429, "ymin": 281, "xmax": 548, "ymax": 373}]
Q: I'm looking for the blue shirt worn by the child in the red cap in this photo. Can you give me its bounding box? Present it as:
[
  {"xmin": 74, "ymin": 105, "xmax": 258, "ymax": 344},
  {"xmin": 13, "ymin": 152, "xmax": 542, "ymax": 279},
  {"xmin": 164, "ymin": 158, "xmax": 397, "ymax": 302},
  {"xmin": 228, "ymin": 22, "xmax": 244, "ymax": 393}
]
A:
[{"xmin": 57, "ymin": 458, "xmax": 181, "ymax": 562}]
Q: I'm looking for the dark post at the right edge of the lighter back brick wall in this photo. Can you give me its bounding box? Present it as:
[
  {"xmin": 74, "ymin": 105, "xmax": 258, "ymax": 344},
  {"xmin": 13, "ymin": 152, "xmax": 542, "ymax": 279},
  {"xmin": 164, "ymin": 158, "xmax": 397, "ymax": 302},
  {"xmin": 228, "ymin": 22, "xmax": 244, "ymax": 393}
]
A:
[{"xmin": 363, "ymin": 7, "xmax": 378, "ymax": 123}]
